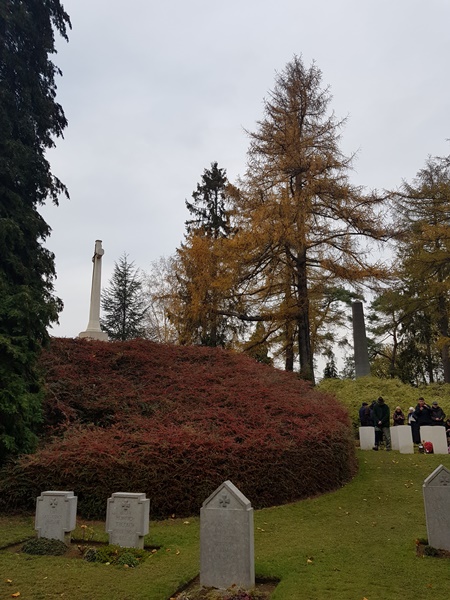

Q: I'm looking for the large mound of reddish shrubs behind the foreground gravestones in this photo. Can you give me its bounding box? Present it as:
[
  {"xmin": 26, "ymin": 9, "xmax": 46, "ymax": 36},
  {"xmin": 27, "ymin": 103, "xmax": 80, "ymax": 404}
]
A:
[{"xmin": 0, "ymin": 339, "xmax": 356, "ymax": 518}]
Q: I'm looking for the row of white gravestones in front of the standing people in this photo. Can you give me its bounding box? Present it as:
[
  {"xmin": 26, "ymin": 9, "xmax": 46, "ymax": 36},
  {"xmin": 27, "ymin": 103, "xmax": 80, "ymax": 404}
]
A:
[{"xmin": 359, "ymin": 425, "xmax": 448, "ymax": 454}]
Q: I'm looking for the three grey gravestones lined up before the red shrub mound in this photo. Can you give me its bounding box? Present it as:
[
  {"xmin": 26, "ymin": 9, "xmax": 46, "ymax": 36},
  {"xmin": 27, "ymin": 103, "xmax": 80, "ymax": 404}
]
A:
[{"xmin": 35, "ymin": 481, "xmax": 255, "ymax": 589}]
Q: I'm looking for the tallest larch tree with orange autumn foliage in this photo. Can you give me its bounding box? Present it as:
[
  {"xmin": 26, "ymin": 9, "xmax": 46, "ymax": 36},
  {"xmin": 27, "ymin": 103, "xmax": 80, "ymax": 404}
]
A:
[{"xmin": 229, "ymin": 56, "xmax": 384, "ymax": 382}]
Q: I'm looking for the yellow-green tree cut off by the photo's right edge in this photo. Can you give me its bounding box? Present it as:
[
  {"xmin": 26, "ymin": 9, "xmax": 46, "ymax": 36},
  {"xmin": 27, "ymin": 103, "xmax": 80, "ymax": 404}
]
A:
[{"xmin": 373, "ymin": 152, "xmax": 450, "ymax": 385}]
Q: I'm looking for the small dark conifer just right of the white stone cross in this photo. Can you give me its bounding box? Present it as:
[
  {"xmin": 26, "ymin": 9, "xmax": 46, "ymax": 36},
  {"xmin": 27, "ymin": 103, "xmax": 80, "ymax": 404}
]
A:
[{"xmin": 101, "ymin": 253, "xmax": 148, "ymax": 341}]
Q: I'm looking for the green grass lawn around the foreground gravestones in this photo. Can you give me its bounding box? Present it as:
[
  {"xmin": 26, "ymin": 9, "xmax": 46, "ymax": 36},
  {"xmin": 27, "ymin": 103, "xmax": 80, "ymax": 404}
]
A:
[{"xmin": 0, "ymin": 451, "xmax": 450, "ymax": 600}]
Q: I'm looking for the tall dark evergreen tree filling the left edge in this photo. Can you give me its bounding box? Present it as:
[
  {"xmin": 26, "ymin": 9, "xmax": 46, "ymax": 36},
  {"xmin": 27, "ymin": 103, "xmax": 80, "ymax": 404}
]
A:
[{"xmin": 0, "ymin": 0, "xmax": 70, "ymax": 462}]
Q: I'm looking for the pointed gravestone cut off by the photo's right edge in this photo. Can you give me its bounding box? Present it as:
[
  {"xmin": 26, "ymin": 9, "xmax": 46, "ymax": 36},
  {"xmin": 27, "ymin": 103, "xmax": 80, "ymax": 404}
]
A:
[{"xmin": 423, "ymin": 465, "xmax": 450, "ymax": 552}]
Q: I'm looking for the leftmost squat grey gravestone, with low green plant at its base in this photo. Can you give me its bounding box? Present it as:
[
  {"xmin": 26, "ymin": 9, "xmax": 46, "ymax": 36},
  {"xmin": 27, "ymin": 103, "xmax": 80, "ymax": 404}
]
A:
[{"xmin": 34, "ymin": 491, "xmax": 77, "ymax": 542}]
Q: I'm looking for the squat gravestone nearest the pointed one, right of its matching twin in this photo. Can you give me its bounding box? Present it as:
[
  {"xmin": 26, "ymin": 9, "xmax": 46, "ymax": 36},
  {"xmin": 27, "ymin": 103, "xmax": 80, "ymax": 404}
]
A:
[{"xmin": 106, "ymin": 492, "xmax": 150, "ymax": 549}]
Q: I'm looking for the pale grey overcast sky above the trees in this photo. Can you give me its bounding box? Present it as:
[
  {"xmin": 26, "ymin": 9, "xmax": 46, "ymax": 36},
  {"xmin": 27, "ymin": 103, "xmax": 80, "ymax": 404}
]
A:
[{"xmin": 42, "ymin": 0, "xmax": 450, "ymax": 337}]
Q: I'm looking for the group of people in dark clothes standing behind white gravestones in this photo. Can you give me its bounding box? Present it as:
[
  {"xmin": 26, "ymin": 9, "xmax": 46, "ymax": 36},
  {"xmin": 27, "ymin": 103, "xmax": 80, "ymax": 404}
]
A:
[{"xmin": 359, "ymin": 396, "xmax": 450, "ymax": 450}]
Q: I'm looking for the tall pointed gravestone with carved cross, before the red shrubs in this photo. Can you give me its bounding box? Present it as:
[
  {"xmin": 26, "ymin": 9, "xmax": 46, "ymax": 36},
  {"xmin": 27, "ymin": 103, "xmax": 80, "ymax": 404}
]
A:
[{"xmin": 200, "ymin": 481, "xmax": 255, "ymax": 589}]
